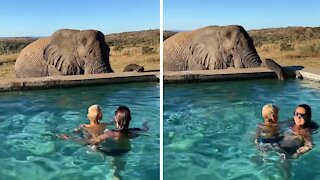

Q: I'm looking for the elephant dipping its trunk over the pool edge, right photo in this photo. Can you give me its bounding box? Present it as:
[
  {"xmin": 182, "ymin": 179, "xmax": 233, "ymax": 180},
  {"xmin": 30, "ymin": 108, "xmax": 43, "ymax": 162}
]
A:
[{"xmin": 163, "ymin": 25, "xmax": 285, "ymax": 80}]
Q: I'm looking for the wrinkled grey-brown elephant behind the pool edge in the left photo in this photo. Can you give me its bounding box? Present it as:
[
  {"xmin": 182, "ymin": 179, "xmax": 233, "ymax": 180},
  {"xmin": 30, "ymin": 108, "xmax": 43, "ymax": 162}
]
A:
[{"xmin": 15, "ymin": 29, "xmax": 113, "ymax": 78}]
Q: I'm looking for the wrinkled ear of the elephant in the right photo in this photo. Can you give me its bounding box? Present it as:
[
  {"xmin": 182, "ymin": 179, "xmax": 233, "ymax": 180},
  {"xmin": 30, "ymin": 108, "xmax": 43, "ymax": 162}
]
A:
[{"xmin": 189, "ymin": 43, "xmax": 228, "ymax": 70}]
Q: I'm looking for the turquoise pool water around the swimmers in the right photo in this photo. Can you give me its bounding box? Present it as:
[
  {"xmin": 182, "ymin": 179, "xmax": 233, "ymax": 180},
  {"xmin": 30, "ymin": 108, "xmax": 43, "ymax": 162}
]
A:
[{"xmin": 163, "ymin": 79, "xmax": 320, "ymax": 180}]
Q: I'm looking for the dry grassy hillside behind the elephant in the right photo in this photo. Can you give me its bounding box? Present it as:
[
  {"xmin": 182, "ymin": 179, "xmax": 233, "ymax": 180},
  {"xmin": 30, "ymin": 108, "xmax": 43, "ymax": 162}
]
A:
[{"xmin": 164, "ymin": 27, "xmax": 320, "ymax": 68}]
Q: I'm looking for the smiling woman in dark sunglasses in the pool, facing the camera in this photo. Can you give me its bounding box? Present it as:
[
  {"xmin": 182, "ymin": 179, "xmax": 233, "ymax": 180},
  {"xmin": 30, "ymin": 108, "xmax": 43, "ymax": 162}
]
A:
[{"xmin": 280, "ymin": 104, "xmax": 313, "ymax": 158}]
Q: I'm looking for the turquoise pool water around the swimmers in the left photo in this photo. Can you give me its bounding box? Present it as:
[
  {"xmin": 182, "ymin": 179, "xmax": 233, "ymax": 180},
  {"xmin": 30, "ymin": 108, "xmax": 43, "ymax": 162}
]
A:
[{"xmin": 0, "ymin": 83, "xmax": 160, "ymax": 179}]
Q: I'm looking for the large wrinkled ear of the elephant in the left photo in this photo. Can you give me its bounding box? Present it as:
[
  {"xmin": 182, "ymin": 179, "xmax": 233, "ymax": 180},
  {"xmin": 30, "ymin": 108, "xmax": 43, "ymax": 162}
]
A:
[{"xmin": 44, "ymin": 29, "xmax": 81, "ymax": 75}]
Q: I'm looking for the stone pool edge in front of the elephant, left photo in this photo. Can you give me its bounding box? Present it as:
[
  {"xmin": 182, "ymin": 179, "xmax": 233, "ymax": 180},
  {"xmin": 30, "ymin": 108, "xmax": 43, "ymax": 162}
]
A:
[{"xmin": 0, "ymin": 71, "xmax": 160, "ymax": 92}]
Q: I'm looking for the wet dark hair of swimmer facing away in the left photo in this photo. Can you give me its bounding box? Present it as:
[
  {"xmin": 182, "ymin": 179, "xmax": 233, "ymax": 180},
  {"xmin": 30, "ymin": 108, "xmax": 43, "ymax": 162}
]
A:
[{"xmin": 115, "ymin": 106, "xmax": 131, "ymax": 132}]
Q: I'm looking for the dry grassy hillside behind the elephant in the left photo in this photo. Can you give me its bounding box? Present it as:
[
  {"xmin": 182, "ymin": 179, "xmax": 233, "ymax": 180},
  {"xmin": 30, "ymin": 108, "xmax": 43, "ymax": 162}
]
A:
[{"xmin": 0, "ymin": 30, "xmax": 160, "ymax": 79}]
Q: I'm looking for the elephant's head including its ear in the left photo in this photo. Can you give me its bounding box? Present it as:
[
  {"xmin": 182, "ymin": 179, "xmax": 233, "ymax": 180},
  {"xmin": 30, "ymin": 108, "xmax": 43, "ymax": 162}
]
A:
[{"xmin": 44, "ymin": 29, "xmax": 113, "ymax": 75}]
